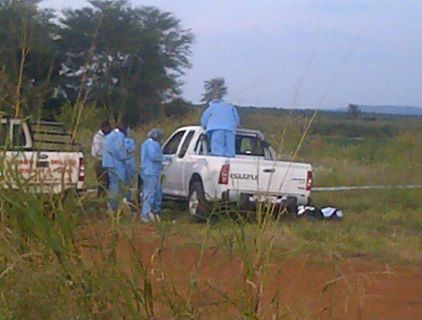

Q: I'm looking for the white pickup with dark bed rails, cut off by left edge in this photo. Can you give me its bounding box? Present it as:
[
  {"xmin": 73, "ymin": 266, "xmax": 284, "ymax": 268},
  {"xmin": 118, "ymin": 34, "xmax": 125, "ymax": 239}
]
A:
[{"xmin": 0, "ymin": 117, "xmax": 85, "ymax": 194}]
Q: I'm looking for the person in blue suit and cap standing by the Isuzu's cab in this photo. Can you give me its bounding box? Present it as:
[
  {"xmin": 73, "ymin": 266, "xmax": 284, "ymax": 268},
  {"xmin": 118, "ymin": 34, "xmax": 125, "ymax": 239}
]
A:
[{"xmin": 141, "ymin": 129, "xmax": 164, "ymax": 222}]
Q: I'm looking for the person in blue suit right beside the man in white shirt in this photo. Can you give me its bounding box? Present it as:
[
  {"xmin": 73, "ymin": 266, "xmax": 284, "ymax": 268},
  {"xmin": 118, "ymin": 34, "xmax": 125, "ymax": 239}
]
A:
[{"xmin": 103, "ymin": 124, "xmax": 128, "ymax": 211}]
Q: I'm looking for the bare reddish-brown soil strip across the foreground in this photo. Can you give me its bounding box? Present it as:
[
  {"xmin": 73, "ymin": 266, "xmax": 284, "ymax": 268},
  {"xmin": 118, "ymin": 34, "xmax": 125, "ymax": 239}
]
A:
[{"xmin": 78, "ymin": 222, "xmax": 422, "ymax": 320}]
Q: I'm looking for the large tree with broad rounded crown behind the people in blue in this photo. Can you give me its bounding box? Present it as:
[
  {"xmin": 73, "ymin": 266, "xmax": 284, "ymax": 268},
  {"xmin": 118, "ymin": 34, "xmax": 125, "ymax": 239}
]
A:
[{"xmin": 56, "ymin": 0, "xmax": 193, "ymax": 125}]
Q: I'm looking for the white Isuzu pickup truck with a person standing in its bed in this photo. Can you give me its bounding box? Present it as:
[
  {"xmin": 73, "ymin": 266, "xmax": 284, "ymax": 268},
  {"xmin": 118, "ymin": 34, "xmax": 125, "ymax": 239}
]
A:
[{"xmin": 163, "ymin": 126, "xmax": 312, "ymax": 217}]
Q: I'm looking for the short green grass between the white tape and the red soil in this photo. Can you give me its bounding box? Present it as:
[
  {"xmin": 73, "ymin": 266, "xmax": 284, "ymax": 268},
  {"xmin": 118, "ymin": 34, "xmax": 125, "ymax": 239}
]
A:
[{"xmin": 155, "ymin": 190, "xmax": 422, "ymax": 264}]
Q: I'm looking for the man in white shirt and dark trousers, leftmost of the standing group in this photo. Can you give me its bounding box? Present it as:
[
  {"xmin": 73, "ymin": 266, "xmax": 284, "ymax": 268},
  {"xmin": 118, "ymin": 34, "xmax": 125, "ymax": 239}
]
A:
[{"xmin": 91, "ymin": 121, "xmax": 111, "ymax": 197}]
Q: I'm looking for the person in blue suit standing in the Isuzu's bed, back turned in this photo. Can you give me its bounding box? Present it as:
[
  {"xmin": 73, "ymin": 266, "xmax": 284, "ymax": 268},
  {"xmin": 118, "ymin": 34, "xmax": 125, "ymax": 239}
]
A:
[{"xmin": 201, "ymin": 100, "xmax": 240, "ymax": 158}]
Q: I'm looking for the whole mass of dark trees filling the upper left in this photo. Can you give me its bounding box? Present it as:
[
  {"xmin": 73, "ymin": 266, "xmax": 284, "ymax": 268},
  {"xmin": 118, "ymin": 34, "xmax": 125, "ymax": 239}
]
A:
[{"xmin": 0, "ymin": 0, "xmax": 194, "ymax": 125}]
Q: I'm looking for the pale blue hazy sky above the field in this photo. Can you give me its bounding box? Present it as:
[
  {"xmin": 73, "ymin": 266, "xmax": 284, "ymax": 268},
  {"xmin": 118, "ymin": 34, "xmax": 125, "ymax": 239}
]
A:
[{"xmin": 42, "ymin": 0, "xmax": 422, "ymax": 109}]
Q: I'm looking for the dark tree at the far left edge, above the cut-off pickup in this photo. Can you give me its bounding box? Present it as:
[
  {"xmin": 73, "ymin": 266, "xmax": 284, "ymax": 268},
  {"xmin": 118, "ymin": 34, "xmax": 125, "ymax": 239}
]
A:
[{"xmin": 0, "ymin": 0, "xmax": 58, "ymax": 116}]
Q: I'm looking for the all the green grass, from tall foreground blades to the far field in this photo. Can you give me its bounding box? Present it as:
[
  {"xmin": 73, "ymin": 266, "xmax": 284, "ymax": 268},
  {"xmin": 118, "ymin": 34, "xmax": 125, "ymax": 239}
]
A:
[{"xmin": 0, "ymin": 110, "xmax": 422, "ymax": 320}]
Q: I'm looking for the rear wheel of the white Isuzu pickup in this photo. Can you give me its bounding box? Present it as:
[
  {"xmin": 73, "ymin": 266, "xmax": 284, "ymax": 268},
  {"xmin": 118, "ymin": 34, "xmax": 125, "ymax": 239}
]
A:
[{"xmin": 188, "ymin": 181, "xmax": 211, "ymax": 222}]
